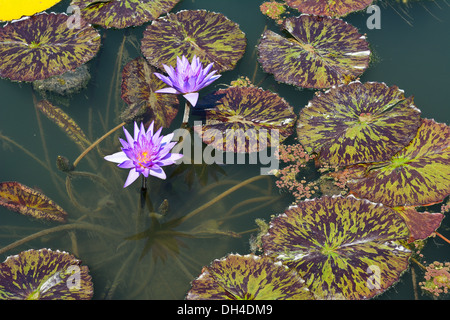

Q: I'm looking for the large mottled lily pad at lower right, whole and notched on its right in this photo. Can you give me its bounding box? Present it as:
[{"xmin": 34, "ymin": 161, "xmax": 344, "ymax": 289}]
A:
[{"xmin": 261, "ymin": 196, "xmax": 411, "ymax": 299}]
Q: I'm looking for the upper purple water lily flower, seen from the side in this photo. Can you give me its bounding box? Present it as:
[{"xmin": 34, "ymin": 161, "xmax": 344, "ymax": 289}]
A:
[{"xmin": 154, "ymin": 56, "xmax": 220, "ymax": 107}]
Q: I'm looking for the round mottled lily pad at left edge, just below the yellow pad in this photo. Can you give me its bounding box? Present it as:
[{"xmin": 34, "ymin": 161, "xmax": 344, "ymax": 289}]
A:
[{"xmin": 0, "ymin": 13, "xmax": 100, "ymax": 81}]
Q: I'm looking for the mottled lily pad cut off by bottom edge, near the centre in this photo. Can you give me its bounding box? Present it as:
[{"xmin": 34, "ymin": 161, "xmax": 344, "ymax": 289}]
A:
[{"xmin": 186, "ymin": 254, "xmax": 313, "ymax": 300}]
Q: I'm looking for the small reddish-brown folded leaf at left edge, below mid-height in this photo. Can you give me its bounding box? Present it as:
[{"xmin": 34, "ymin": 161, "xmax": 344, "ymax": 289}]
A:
[{"xmin": 0, "ymin": 181, "xmax": 67, "ymax": 222}]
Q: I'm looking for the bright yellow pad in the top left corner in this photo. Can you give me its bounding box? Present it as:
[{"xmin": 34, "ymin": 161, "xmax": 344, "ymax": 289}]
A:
[{"xmin": 0, "ymin": 0, "xmax": 61, "ymax": 21}]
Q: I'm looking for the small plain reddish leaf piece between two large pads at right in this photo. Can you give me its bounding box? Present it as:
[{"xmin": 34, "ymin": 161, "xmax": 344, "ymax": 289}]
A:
[{"xmin": 393, "ymin": 207, "xmax": 444, "ymax": 241}]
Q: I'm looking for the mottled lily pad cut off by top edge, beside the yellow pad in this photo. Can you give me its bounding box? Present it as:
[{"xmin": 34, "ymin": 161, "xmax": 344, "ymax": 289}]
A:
[{"xmin": 71, "ymin": 0, "xmax": 180, "ymax": 29}]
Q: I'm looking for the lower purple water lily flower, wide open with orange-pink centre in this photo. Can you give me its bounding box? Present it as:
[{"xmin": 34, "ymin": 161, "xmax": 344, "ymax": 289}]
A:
[{"xmin": 104, "ymin": 122, "xmax": 183, "ymax": 188}]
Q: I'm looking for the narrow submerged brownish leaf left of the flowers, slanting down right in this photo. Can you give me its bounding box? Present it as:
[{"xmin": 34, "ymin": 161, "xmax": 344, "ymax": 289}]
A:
[{"xmin": 36, "ymin": 100, "xmax": 91, "ymax": 148}]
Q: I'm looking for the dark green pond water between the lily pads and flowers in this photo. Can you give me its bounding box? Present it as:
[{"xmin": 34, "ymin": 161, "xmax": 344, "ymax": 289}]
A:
[{"xmin": 0, "ymin": 0, "xmax": 450, "ymax": 299}]
